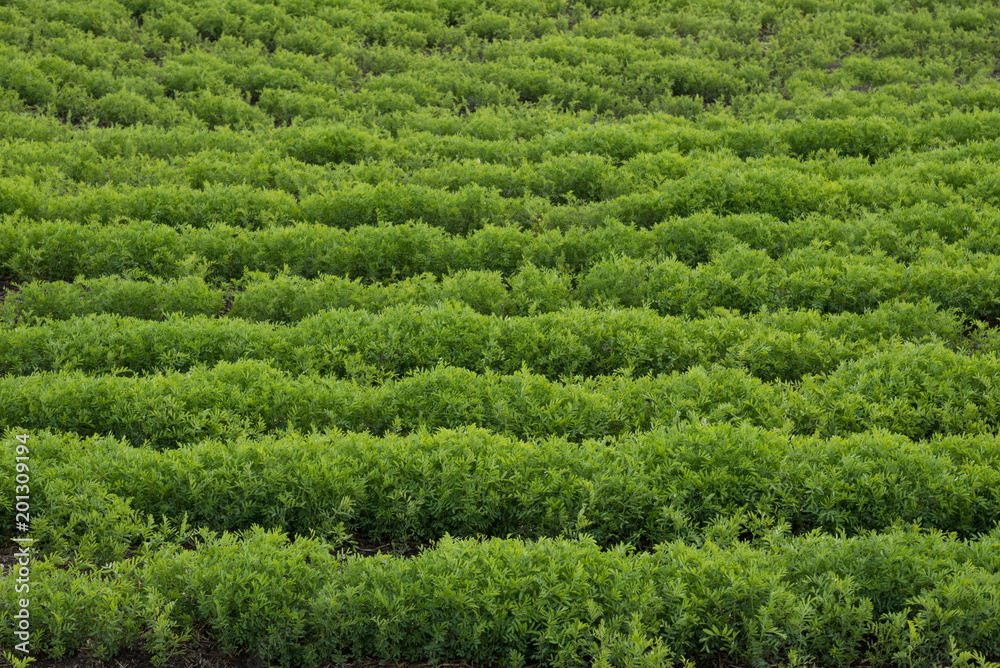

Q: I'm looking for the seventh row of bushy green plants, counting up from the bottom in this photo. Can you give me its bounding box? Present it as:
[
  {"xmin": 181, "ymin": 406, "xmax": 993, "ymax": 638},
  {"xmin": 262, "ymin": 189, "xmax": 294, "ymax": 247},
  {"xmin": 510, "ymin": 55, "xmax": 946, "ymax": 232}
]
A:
[{"xmin": 0, "ymin": 141, "xmax": 1000, "ymax": 230}]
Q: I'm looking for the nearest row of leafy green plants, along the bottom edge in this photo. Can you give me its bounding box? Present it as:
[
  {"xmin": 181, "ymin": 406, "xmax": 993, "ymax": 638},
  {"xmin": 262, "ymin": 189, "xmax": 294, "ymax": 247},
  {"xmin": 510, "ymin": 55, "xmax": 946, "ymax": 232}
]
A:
[{"xmin": 0, "ymin": 515, "xmax": 1000, "ymax": 668}]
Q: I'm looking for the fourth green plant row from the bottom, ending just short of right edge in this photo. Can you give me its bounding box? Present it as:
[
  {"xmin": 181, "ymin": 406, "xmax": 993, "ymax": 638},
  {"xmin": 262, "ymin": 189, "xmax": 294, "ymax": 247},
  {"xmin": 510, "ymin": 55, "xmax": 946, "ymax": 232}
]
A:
[{"xmin": 0, "ymin": 302, "xmax": 963, "ymax": 381}]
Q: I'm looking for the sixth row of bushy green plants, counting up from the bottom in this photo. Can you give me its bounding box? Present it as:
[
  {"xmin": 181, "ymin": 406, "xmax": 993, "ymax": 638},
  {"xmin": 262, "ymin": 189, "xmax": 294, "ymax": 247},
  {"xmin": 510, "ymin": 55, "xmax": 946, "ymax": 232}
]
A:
[{"xmin": 0, "ymin": 203, "xmax": 1000, "ymax": 284}]
